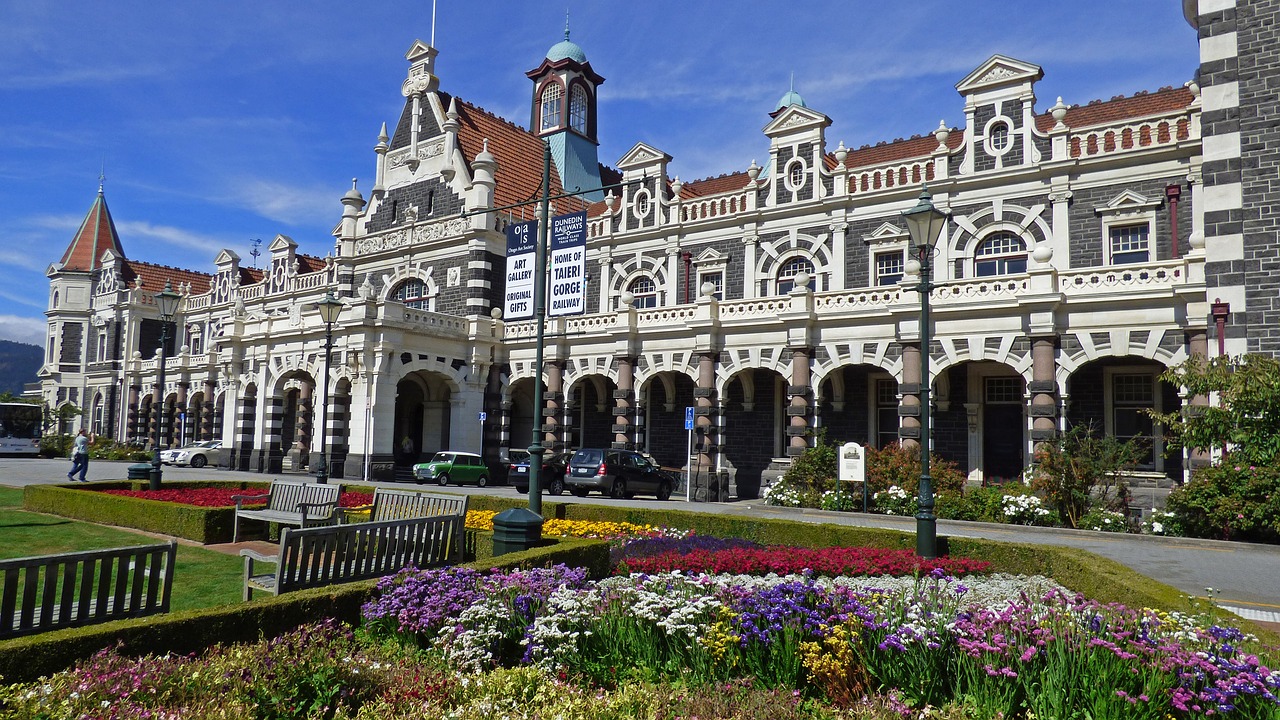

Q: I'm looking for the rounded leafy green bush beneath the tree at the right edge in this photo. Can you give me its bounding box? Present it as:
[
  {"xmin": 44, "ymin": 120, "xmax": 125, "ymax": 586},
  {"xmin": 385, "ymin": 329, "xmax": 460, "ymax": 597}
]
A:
[{"xmin": 1165, "ymin": 454, "xmax": 1280, "ymax": 542}]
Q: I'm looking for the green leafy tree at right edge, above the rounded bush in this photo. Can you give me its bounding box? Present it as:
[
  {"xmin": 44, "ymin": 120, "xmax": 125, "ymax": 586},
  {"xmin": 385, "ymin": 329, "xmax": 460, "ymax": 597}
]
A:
[{"xmin": 1151, "ymin": 355, "xmax": 1280, "ymax": 465}]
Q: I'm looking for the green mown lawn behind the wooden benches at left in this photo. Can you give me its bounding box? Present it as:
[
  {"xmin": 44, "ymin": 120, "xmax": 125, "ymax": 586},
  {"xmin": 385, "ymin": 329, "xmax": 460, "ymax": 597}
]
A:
[{"xmin": 0, "ymin": 488, "xmax": 244, "ymax": 611}]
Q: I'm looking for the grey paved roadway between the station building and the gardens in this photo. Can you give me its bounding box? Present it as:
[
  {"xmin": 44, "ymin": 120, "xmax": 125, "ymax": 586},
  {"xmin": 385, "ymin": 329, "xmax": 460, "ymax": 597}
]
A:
[{"xmin": 0, "ymin": 457, "xmax": 1280, "ymax": 624}]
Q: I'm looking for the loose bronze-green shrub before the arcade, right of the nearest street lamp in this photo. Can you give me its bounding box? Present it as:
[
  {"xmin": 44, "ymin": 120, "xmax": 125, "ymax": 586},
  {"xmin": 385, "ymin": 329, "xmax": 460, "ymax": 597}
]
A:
[{"xmin": 1032, "ymin": 425, "xmax": 1143, "ymax": 528}]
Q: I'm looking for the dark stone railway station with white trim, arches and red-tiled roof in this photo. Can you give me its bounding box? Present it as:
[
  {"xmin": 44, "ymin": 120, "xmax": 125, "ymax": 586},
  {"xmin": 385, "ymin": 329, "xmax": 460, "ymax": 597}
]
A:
[{"xmin": 42, "ymin": 0, "xmax": 1280, "ymax": 497}]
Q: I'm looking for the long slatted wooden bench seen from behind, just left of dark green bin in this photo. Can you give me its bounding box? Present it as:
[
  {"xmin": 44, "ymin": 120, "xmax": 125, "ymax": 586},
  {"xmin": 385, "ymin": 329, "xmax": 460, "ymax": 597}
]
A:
[{"xmin": 241, "ymin": 515, "xmax": 466, "ymax": 600}]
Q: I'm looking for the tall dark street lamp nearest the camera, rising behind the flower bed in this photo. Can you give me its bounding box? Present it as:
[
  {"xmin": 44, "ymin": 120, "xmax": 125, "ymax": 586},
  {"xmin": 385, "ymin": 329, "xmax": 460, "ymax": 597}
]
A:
[{"xmin": 902, "ymin": 186, "xmax": 951, "ymax": 559}]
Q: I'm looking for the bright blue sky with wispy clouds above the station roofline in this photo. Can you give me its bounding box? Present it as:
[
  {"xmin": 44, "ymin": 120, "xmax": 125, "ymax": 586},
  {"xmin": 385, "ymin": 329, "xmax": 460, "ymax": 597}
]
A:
[{"xmin": 0, "ymin": 0, "xmax": 1197, "ymax": 345}]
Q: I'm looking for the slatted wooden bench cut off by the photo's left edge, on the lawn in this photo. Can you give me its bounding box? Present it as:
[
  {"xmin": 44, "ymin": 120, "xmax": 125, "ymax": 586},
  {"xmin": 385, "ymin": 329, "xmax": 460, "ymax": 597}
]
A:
[{"xmin": 0, "ymin": 541, "xmax": 178, "ymax": 638}]
